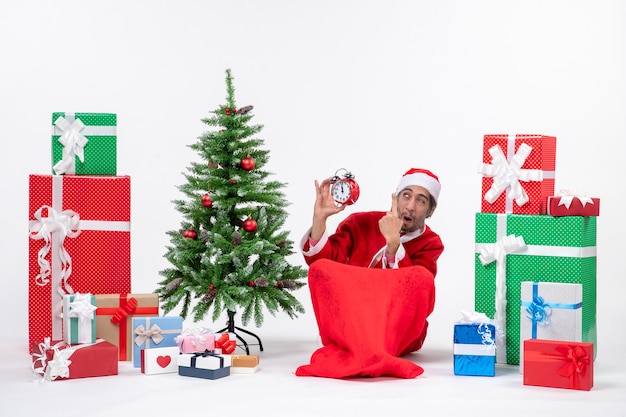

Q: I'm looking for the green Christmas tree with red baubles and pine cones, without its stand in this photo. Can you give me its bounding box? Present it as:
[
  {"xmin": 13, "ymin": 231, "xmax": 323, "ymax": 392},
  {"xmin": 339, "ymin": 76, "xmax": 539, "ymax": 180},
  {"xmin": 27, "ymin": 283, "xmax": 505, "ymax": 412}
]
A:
[{"xmin": 156, "ymin": 70, "xmax": 307, "ymax": 334}]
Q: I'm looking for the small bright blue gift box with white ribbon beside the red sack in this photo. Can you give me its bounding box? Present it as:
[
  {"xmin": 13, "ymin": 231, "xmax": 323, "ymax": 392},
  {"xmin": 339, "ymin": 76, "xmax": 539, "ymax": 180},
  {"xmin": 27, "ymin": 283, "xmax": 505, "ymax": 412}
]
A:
[{"xmin": 454, "ymin": 323, "xmax": 496, "ymax": 376}]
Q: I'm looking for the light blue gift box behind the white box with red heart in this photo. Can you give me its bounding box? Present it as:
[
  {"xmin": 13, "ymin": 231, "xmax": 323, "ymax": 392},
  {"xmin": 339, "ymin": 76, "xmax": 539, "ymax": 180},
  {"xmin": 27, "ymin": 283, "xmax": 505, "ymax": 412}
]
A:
[{"xmin": 133, "ymin": 316, "xmax": 183, "ymax": 368}]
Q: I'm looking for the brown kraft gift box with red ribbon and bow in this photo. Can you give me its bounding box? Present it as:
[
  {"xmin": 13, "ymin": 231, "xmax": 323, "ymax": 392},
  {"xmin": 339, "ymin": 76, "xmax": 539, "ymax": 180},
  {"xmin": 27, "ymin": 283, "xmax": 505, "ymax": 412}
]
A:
[{"xmin": 96, "ymin": 293, "xmax": 159, "ymax": 361}]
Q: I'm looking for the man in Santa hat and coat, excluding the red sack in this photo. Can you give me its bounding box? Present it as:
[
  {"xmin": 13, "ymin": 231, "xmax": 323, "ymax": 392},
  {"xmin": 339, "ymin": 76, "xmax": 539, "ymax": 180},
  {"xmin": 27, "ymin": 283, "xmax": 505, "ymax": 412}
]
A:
[{"xmin": 301, "ymin": 168, "xmax": 443, "ymax": 275}]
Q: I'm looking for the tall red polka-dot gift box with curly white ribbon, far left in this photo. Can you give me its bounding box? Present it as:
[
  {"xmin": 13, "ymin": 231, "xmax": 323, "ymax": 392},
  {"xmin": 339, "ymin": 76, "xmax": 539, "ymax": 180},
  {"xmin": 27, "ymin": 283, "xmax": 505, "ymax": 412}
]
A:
[{"xmin": 28, "ymin": 175, "xmax": 131, "ymax": 353}]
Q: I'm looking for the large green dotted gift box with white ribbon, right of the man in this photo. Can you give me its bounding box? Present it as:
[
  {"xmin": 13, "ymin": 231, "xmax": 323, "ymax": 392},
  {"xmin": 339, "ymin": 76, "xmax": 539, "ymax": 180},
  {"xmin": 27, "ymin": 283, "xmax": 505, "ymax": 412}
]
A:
[{"xmin": 474, "ymin": 213, "xmax": 597, "ymax": 365}]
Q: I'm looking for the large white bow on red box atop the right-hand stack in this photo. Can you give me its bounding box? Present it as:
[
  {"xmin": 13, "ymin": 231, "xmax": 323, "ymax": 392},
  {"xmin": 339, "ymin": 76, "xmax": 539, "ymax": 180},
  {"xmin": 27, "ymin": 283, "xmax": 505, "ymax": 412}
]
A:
[{"xmin": 478, "ymin": 143, "xmax": 543, "ymax": 206}]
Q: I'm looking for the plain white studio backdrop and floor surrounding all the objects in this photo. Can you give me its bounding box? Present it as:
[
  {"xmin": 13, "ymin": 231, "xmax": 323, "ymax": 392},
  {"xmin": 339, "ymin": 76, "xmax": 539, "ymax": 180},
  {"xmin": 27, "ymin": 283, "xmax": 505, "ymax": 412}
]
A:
[{"xmin": 0, "ymin": 0, "xmax": 626, "ymax": 416}]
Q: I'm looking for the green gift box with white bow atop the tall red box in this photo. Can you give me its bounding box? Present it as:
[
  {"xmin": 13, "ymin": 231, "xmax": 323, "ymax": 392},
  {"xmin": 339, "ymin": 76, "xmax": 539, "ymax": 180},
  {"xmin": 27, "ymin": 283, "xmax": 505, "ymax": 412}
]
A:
[{"xmin": 52, "ymin": 112, "xmax": 117, "ymax": 175}]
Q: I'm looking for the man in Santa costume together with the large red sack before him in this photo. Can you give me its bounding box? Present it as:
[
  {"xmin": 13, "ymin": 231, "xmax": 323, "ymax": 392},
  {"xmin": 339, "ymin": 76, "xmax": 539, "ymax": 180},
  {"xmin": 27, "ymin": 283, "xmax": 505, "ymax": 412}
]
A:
[{"xmin": 296, "ymin": 168, "xmax": 444, "ymax": 378}]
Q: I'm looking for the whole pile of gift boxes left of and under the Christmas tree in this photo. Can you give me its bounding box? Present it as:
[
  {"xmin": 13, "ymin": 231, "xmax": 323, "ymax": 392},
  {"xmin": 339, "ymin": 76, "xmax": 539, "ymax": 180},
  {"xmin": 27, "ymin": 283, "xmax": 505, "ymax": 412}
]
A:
[{"xmin": 28, "ymin": 113, "xmax": 258, "ymax": 380}]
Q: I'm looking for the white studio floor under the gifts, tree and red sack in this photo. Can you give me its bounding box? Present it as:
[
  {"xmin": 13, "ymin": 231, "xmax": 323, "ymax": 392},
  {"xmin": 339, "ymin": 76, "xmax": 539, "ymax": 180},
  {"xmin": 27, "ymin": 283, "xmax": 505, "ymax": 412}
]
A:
[{"xmin": 0, "ymin": 324, "xmax": 626, "ymax": 417}]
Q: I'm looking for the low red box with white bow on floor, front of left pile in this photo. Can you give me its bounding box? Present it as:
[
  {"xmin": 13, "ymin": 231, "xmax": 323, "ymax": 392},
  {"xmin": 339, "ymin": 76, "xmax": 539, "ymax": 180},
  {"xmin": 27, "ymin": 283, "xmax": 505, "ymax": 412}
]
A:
[{"xmin": 32, "ymin": 338, "xmax": 118, "ymax": 381}]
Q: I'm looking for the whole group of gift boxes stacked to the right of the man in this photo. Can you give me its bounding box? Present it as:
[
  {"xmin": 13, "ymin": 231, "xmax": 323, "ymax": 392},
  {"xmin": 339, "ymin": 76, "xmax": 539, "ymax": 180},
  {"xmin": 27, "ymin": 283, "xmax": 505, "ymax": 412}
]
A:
[{"xmin": 455, "ymin": 135, "xmax": 600, "ymax": 390}]
